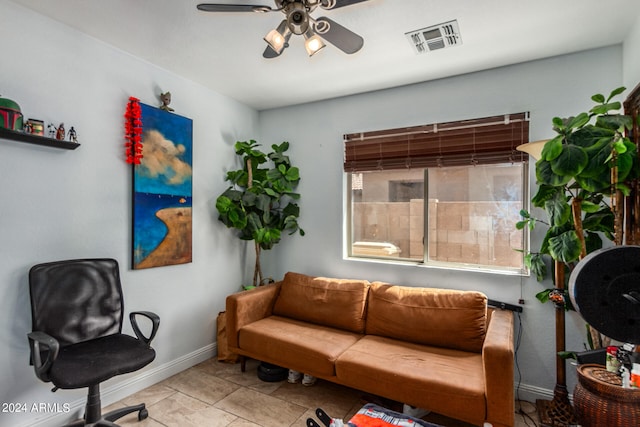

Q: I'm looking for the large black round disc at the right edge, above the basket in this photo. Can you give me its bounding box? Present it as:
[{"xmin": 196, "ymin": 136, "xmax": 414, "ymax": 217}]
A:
[{"xmin": 569, "ymin": 246, "xmax": 640, "ymax": 344}]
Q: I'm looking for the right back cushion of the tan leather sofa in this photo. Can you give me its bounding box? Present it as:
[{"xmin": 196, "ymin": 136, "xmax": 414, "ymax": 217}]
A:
[{"xmin": 366, "ymin": 282, "xmax": 487, "ymax": 353}]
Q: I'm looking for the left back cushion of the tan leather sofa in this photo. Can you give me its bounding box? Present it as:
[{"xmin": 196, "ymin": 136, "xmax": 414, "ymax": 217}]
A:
[{"xmin": 273, "ymin": 272, "xmax": 370, "ymax": 333}]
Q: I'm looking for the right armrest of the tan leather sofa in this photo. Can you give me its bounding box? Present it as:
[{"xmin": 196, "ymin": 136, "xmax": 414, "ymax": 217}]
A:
[{"xmin": 482, "ymin": 309, "xmax": 515, "ymax": 426}]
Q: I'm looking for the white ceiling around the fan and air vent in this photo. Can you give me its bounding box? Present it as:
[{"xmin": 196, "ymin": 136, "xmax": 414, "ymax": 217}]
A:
[{"xmin": 12, "ymin": 0, "xmax": 640, "ymax": 110}]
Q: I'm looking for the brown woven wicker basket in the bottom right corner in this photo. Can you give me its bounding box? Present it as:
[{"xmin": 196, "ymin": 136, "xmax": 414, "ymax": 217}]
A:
[{"xmin": 573, "ymin": 364, "xmax": 640, "ymax": 427}]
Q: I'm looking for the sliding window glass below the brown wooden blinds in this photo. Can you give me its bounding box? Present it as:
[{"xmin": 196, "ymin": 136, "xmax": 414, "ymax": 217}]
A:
[{"xmin": 349, "ymin": 163, "xmax": 525, "ymax": 270}]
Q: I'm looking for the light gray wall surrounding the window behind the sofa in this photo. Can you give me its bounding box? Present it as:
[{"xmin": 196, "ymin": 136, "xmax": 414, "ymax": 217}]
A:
[{"xmin": 260, "ymin": 46, "xmax": 622, "ymax": 399}]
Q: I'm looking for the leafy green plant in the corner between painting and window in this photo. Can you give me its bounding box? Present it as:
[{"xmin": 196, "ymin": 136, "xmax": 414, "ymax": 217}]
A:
[{"xmin": 216, "ymin": 140, "xmax": 304, "ymax": 286}]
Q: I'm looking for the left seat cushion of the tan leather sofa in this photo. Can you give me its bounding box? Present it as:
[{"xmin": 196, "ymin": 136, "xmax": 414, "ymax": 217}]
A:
[{"xmin": 239, "ymin": 316, "xmax": 362, "ymax": 378}]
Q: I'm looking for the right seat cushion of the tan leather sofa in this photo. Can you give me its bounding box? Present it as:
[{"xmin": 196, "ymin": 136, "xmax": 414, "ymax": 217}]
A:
[{"xmin": 336, "ymin": 335, "xmax": 482, "ymax": 425}]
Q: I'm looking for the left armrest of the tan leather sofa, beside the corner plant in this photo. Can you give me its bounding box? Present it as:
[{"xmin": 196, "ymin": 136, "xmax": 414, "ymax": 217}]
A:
[{"xmin": 226, "ymin": 282, "xmax": 281, "ymax": 349}]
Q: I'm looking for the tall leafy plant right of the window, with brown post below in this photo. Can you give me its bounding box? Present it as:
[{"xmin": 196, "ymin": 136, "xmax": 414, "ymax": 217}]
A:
[{"xmin": 516, "ymin": 87, "xmax": 640, "ymax": 421}]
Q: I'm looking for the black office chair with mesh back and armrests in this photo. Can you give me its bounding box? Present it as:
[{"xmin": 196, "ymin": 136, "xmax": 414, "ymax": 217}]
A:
[{"xmin": 28, "ymin": 259, "xmax": 160, "ymax": 427}]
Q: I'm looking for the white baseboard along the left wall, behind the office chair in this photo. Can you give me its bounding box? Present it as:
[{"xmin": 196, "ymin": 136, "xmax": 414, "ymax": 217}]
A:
[{"xmin": 17, "ymin": 343, "xmax": 218, "ymax": 427}]
